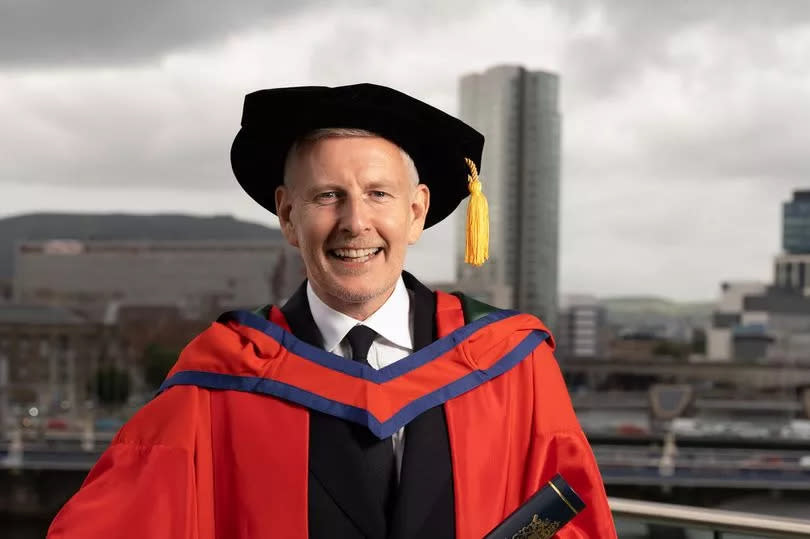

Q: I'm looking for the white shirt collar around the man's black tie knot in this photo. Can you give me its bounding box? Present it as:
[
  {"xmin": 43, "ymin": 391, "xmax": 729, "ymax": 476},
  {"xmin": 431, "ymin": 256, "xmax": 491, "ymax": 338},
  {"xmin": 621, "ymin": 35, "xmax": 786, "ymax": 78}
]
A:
[{"xmin": 307, "ymin": 277, "xmax": 413, "ymax": 352}]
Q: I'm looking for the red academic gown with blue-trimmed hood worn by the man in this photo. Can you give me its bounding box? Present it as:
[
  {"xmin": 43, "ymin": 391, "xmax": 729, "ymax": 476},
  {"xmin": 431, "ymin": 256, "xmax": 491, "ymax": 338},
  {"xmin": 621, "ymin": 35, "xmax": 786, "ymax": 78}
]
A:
[{"xmin": 48, "ymin": 280, "xmax": 616, "ymax": 539}]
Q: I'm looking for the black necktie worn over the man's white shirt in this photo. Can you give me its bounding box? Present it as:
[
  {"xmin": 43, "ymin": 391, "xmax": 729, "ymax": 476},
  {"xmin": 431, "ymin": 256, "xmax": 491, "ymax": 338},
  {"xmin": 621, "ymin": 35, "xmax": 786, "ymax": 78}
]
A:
[{"xmin": 346, "ymin": 325, "xmax": 396, "ymax": 523}]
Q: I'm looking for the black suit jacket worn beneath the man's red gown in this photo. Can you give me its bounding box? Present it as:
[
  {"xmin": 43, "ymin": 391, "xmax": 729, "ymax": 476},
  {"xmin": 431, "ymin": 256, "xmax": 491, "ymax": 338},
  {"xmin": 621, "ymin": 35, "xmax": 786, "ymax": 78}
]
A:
[{"xmin": 281, "ymin": 272, "xmax": 455, "ymax": 539}]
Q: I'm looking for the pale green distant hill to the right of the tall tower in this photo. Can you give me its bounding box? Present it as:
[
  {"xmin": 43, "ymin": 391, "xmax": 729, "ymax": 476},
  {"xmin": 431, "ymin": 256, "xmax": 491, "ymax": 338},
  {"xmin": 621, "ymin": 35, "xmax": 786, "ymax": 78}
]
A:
[{"xmin": 600, "ymin": 296, "xmax": 714, "ymax": 326}]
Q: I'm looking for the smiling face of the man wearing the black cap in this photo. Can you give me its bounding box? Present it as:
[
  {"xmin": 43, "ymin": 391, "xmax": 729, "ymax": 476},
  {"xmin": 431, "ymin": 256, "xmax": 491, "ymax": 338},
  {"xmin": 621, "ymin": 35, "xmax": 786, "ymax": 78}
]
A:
[{"xmin": 276, "ymin": 137, "xmax": 430, "ymax": 320}]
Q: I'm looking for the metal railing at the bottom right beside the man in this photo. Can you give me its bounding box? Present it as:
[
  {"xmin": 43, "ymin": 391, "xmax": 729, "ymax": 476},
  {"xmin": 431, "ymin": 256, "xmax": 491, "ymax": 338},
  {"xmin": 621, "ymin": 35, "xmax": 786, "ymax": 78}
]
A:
[{"xmin": 609, "ymin": 498, "xmax": 810, "ymax": 538}]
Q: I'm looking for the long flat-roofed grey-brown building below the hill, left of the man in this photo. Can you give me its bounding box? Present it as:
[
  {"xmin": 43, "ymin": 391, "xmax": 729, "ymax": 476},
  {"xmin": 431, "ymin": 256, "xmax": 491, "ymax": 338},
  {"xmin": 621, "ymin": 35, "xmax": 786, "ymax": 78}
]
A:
[{"xmin": 12, "ymin": 237, "xmax": 304, "ymax": 321}]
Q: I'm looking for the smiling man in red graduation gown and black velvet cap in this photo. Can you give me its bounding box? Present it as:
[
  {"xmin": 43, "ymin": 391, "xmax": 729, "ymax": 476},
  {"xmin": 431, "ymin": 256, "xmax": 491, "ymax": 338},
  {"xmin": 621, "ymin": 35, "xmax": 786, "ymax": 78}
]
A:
[{"xmin": 49, "ymin": 84, "xmax": 615, "ymax": 539}]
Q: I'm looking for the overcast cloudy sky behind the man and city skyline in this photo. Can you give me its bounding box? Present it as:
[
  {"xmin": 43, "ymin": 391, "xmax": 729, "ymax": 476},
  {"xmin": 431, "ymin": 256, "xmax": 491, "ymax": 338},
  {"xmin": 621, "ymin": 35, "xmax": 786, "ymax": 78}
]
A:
[{"xmin": 0, "ymin": 0, "xmax": 810, "ymax": 299}]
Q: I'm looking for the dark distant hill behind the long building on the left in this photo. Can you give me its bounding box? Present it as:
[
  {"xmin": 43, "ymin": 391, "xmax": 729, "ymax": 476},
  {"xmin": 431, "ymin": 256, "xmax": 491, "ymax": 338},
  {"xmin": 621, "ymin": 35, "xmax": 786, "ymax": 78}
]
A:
[{"xmin": 0, "ymin": 213, "xmax": 281, "ymax": 280}]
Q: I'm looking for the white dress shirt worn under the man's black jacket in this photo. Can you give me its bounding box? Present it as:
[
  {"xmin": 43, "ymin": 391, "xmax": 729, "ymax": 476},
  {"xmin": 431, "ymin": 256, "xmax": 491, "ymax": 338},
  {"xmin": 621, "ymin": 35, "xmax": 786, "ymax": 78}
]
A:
[{"xmin": 307, "ymin": 277, "xmax": 413, "ymax": 478}]
